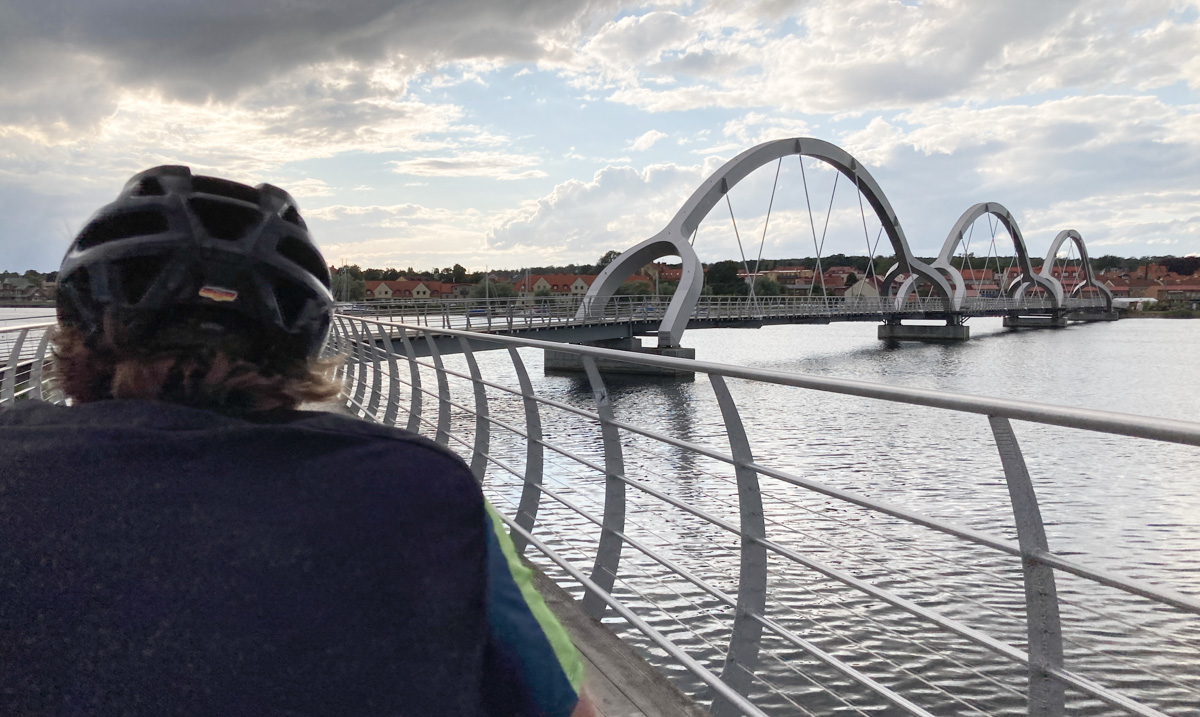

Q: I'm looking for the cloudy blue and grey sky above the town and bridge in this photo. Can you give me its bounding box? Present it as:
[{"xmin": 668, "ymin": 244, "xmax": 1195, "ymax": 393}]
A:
[{"xmin": 0, "ymin": 0, "xmax": 1200, "ymax": 271}]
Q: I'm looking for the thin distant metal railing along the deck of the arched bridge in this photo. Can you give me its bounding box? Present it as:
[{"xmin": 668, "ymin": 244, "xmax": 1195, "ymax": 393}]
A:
[{"xmin": 343, "ymin": 296, "xmax": 1104, "ymax": 332}]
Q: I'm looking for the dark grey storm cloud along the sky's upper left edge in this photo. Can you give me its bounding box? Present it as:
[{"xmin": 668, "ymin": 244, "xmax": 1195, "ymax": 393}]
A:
[{"xmin": 0, "ymin": 0, "xmax": 604, "ymax": 125}]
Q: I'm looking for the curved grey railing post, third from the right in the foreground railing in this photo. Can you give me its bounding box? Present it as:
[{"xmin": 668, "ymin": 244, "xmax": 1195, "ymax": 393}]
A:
[{"xmin": 582, "ymin": 356, "xmax": 625, "ymax": 620}]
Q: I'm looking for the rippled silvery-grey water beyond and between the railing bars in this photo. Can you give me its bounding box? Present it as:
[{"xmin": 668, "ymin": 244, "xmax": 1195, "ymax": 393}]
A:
[{"xmin": 11, "ymin": 309, "xmax": 1200, "ymax": 716}]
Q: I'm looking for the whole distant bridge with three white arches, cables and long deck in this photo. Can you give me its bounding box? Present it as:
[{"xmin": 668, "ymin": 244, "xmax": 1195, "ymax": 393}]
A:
[{"xmin": 352, "ymin": 138, "xmax": 1116, "ymax": 349}]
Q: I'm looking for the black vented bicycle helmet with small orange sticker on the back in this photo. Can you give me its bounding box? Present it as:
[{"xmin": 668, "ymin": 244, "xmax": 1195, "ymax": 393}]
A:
[{"xmin": 58, "ymin": 165, "xmax": 334, "ymax": 360}]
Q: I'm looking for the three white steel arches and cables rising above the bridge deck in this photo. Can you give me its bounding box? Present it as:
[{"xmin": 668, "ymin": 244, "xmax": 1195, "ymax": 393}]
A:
[{"xmin": 575, "ymin": 138, "xmax": 1112, "ymax": 349}]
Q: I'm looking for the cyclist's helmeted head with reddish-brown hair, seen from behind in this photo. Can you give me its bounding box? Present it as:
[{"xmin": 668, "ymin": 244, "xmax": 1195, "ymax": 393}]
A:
[{"xmin": 55, "ymin": 165, "xmax": 334, "ymax": 411}]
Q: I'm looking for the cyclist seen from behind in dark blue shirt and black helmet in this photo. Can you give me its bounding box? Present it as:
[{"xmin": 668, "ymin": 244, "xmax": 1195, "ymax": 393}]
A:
[{"xmin": 0, "ymin": 167, "xmax": 593, "ymax": 717}]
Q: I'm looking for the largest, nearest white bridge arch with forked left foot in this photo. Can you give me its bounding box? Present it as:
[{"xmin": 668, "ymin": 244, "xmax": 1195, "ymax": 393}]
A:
[{"xmin": 576, "ymin": 138, "xmax": 953, "ymax": 348}]
